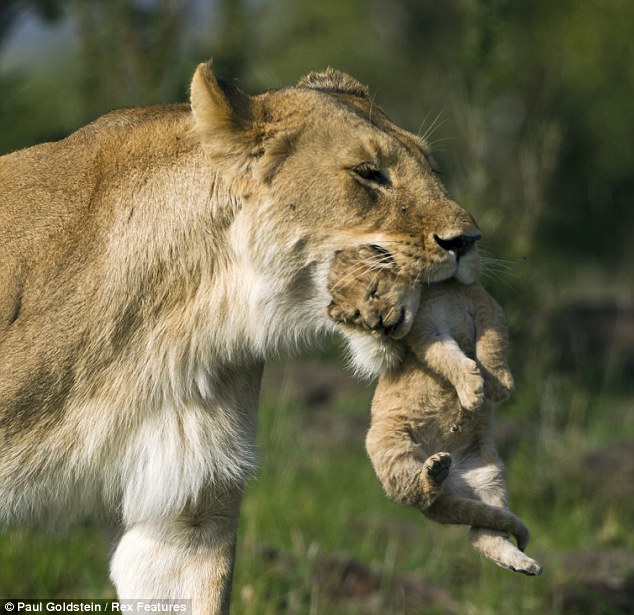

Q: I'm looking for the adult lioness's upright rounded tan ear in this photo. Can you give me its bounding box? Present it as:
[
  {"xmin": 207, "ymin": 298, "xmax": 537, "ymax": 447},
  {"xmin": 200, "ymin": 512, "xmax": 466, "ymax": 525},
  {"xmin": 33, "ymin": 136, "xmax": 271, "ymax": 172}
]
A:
[{"xmin": 191, "ymin": 61, "xmax": 258, "ymax": 186}]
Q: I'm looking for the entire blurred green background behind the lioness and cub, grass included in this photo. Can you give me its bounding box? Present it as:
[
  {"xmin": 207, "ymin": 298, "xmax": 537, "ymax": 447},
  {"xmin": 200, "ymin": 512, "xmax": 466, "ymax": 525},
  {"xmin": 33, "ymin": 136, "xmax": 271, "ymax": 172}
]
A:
[{"xmin": 0, "ymin": 0, "xmax": 634, "ymax": 615}]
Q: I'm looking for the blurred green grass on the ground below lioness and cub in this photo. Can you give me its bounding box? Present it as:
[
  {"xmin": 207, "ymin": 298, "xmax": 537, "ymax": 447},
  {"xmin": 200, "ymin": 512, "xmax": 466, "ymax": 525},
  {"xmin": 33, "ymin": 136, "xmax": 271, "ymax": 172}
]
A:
[{"xmin": 0, "ymin": 358, "xmax": 634, "ymax": 615}]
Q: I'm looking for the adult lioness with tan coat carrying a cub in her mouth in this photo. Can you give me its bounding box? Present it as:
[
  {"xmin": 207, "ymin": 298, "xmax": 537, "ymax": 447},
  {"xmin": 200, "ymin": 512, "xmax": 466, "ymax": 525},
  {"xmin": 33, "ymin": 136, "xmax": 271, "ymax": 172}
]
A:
[{"xmin": 0, "ymin": 63, "xmax": 480, "ymax": 615}]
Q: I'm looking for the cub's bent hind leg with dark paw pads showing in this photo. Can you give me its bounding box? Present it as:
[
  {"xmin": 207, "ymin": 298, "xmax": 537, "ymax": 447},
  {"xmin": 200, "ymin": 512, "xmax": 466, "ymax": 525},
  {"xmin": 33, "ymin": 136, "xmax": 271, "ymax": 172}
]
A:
[{"xmin": 366, "ymin": 417, "xmax": 451, "ymax": 510}]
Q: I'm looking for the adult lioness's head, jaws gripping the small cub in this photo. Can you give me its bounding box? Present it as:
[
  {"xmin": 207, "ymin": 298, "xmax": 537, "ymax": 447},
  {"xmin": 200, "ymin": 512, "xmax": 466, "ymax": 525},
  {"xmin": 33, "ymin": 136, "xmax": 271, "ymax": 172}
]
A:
[{"xmin": 191, "ymin": 64, "xmax": 480, "ymax": 370}]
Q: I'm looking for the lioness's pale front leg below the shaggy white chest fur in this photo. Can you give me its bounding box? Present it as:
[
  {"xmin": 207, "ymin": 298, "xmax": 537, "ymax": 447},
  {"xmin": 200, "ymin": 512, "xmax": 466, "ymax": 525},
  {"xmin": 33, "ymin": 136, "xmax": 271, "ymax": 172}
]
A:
[{"xmin": 111, "ymin": 490, "xmax": 240, "ymax": 615}]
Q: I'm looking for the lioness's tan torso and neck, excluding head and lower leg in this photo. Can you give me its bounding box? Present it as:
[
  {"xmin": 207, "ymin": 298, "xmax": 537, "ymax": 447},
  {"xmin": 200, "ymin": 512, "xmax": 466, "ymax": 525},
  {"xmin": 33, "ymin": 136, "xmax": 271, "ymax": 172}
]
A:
[{"xmin": 0, "ymin": 107, "xmax": 328, "ymax": 519}]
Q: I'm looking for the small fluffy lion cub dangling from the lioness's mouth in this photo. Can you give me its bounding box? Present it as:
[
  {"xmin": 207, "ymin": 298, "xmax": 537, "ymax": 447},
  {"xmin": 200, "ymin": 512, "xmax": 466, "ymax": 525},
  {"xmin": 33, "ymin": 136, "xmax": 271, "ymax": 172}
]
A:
[{"xmin": 328, "ymin": 246, "xmax": 542, "ymax": 575}]
